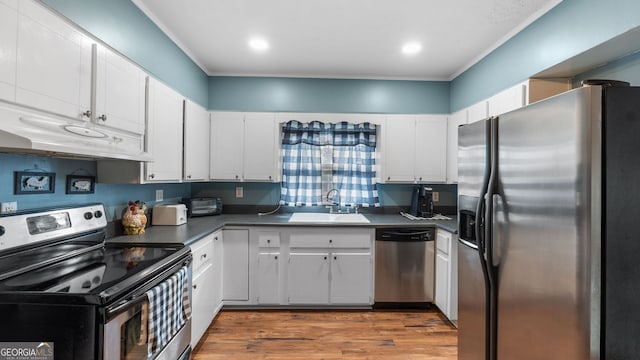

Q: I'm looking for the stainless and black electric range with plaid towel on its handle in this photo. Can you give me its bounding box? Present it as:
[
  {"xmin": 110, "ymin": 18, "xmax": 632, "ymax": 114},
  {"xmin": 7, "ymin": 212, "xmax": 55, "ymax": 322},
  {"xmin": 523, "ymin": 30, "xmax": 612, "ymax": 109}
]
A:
[{"xmin": 0, "ymin": 204, "xmax": 191, "ymax": 360}]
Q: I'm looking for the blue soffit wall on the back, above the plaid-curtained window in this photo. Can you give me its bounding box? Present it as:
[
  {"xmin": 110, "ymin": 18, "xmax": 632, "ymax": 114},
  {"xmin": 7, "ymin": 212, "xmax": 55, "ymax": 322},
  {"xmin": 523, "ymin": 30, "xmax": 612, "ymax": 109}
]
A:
[{"xmin": 209, "ymin": 76, "xmax": 449, "ymax": 114}]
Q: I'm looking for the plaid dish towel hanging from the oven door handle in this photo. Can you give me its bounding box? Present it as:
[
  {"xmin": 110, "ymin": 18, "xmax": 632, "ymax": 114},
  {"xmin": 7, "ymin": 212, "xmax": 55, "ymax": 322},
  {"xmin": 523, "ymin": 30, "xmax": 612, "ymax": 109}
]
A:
[{"xmin": 147, "ymin": 266, "xmax": 191, "ymax": 354}]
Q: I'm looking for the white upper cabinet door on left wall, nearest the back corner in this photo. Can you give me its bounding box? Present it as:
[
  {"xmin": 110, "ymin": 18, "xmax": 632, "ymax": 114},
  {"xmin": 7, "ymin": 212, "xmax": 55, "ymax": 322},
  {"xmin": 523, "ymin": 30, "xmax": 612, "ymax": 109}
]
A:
[{"xmin": 184, "ymin": 100, "xmax": 210, "ymax": 181}]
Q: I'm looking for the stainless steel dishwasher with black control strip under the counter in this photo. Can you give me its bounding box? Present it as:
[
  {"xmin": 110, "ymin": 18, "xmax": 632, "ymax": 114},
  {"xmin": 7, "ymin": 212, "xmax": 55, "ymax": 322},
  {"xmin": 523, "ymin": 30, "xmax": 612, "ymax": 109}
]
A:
[{"xmin": 374, "ymin": 227, "xmax": 436, "ymax": 306}]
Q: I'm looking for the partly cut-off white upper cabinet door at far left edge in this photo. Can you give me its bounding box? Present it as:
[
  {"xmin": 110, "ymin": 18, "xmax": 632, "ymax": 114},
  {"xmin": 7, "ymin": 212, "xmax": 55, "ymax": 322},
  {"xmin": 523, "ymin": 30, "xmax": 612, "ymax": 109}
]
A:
[{"xmin": 0, "ymin": 1, "xmax": 18, "ymax": 101}]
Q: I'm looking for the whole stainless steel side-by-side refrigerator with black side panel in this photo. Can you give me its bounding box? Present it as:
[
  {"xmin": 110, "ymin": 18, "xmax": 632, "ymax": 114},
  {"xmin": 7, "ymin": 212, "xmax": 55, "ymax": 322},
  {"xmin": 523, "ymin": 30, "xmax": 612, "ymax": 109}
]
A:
[{"xmin": 458, "ymin": 85, "xmax": 640, "ymax": 360}]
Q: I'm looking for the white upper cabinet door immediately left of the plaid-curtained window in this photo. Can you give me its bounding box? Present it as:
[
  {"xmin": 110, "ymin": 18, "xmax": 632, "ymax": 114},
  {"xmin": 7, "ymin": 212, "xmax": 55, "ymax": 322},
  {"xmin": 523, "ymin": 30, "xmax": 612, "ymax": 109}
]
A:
[{"xmin": 244, "ymin": 113, "xmax": 280, "ymax": 181}]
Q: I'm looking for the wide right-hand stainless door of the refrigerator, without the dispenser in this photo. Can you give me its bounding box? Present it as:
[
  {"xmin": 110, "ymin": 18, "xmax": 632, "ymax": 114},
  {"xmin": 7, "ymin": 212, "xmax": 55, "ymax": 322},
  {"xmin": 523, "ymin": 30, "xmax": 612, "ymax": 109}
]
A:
[{"xmin": 492, "ymin": 87, "xmax": 602, "ymax": 360}]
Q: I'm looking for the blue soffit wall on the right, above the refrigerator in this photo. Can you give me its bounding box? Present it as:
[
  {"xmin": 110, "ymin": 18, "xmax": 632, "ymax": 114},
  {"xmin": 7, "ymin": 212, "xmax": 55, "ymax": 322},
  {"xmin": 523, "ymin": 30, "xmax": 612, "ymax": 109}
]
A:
[{"xmin": 450, "ymin": 0, "xmax": 640, "ymax": 112}]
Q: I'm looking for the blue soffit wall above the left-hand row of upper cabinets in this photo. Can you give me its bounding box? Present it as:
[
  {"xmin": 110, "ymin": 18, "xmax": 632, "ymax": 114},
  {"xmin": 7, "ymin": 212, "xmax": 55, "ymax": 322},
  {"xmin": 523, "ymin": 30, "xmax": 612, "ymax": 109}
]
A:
[{"xmin": 42, "ymin": 0, "xmax": 209, "ymax": 107}]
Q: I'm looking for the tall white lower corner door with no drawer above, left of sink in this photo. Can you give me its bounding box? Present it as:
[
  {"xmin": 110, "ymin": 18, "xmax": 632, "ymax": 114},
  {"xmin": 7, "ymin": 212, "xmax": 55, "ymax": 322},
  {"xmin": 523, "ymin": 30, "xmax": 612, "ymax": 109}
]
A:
[{"xmin": 222, "ymin": 230, "xmax": 249, "ymax": 301}]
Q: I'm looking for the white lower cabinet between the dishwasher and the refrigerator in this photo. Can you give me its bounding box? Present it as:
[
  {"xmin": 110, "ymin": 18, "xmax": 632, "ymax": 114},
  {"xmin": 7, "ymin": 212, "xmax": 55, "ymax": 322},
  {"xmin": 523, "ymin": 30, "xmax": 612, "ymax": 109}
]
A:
[{"xmin": 435, "ymin": 229, "xmax": 458, "ymax": 321}]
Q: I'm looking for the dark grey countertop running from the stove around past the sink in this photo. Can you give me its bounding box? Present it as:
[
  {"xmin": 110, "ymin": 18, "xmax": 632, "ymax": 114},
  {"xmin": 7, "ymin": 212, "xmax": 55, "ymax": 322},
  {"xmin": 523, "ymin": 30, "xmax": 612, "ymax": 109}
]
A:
[{"xmin": 107, "ymin": 213, "xmax": 458, "ymax": 245}]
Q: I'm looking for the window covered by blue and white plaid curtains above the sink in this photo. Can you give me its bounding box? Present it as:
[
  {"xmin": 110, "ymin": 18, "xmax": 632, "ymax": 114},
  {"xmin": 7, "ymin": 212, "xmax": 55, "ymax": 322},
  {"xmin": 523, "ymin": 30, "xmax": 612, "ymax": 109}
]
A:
[{"xmin": 280, "ymin": 120, "xmax": 380, "ymax": 207}]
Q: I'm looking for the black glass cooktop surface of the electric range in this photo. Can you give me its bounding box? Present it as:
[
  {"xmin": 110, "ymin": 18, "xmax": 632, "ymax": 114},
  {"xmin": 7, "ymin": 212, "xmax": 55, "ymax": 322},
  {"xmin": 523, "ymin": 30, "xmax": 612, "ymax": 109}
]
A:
[{"xmin": 0, "ymin": 244, "xmax": 183, "ymax": 294}]
